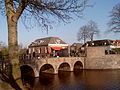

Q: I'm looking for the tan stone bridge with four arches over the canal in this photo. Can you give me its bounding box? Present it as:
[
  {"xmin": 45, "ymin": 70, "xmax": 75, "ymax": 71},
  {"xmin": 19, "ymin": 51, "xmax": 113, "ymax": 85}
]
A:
[{"xmin": 20, "ymin": 57, "xmax": 84, "ymax": 77}]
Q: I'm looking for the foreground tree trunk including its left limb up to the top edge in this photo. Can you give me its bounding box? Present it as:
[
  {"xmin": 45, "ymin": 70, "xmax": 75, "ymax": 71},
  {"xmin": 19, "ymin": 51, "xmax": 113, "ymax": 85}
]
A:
[{"xmin": 5, "ymin": 0, "xmax": 23, "ymax": 90}]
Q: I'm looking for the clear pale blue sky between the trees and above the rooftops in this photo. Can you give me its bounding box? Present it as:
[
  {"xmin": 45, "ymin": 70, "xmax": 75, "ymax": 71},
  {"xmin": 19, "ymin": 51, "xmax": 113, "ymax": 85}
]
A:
[{"xmin": 0, "ymin": 0, "xmax": 120, "ymax": 46}]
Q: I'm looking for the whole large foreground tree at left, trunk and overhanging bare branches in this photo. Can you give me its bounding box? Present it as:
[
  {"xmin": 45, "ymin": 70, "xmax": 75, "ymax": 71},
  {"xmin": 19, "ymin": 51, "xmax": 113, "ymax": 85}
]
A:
[{"xmin": 0, "ymin": 0, "xmax": 87, "ymax": 88}]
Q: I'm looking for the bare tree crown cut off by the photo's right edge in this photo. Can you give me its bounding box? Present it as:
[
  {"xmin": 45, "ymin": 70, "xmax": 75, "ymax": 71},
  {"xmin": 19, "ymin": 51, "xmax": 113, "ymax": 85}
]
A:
[{"xmin": 108, "ymin": 3, "xmax": 120, "ymax": 32}]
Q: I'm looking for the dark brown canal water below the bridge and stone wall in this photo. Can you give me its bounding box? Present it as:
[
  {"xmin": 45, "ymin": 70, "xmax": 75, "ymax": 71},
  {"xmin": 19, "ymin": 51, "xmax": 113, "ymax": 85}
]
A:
[{"xmin": 23, "ymin": 70, "xmax": 120, "ymax": 90}]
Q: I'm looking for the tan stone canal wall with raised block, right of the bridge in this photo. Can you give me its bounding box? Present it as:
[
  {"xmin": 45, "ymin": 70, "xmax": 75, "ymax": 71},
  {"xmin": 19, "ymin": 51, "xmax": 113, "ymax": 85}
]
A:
[{"xmin": 84, "ymin": 47, "xmax": 120, "ymax": 69}]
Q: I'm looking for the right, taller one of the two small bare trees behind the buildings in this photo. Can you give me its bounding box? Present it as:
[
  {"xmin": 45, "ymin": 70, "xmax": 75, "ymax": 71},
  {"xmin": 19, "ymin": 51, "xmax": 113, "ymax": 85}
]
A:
[{"xmin": 87, "ymin": 20, "xmax": 99, "ymax": 41}]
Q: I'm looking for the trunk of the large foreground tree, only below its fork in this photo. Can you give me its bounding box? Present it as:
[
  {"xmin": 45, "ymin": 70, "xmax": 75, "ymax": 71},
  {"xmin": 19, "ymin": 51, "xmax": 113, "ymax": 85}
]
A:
[{"xmin": 7, "ymin": 18, "xmax": 22, "ymax": 89}]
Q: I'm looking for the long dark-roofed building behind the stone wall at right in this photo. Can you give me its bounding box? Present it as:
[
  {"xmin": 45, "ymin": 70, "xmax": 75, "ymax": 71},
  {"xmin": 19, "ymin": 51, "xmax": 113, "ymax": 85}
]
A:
[{"xmin": 82, "ymin": 40, "xmax": 120, "ymax": 54}]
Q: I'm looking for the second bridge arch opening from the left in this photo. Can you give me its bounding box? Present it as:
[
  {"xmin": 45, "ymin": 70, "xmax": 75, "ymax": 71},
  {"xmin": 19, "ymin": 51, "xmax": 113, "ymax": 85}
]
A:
[{"xmin": 39, "ymin": 64, "xmax": 55, "ymax": 74}]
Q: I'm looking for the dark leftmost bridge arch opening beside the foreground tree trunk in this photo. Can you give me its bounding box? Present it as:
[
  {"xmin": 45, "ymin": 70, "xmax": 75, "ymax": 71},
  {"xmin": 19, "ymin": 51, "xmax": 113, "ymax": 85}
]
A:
[{"xmin": 20, "ymin": 65, "xmax": 35, "ymax": 77}]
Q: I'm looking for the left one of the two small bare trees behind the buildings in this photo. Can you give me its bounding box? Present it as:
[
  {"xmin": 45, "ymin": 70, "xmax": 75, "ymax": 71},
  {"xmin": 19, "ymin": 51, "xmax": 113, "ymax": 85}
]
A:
[{"xmin": 77, "ymin": 25, "xmax": 89, "ymax": 43}]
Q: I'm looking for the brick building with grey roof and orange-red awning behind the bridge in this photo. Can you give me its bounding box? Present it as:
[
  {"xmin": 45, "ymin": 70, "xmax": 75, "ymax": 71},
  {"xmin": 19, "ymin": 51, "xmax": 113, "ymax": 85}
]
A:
[{"xmin": 28, "ymin": 37, "xmax": 69, "ymax": 57}]
